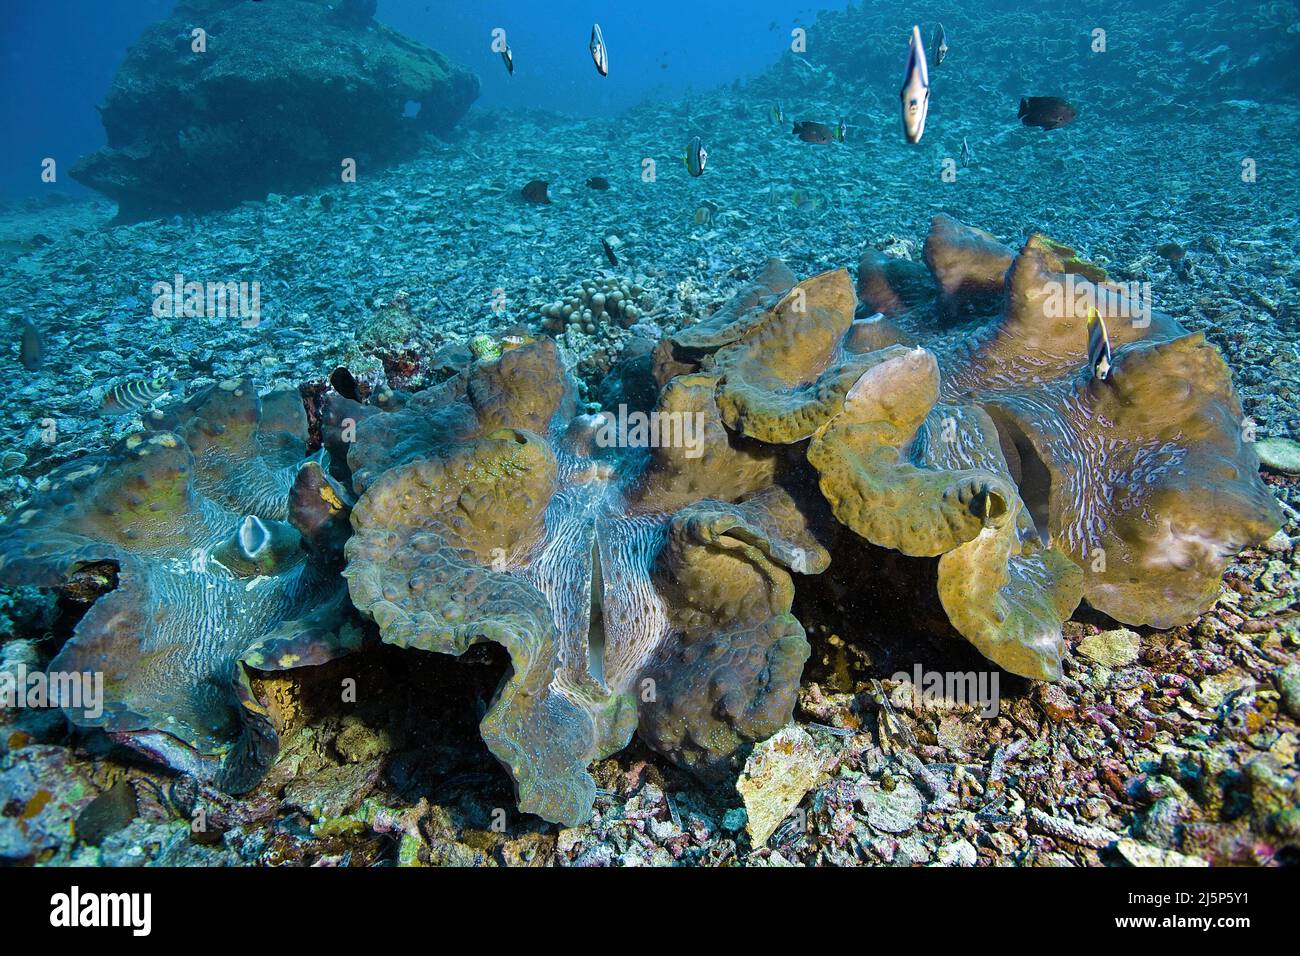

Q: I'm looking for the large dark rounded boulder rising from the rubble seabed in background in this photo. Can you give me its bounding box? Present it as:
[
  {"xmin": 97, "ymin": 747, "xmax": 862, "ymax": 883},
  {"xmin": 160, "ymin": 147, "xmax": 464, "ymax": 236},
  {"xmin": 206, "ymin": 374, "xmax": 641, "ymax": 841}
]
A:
[{"xmin": 72, "ymin": 0, "xmax": 478, "ymax": 221}]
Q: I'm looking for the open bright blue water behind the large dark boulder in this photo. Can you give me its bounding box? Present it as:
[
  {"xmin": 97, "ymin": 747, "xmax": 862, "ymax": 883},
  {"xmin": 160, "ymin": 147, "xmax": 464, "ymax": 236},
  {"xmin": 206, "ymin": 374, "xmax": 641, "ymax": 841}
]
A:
[{"xmin": 0, "ymin": 0, "xmax": 844, "ymax": 198}]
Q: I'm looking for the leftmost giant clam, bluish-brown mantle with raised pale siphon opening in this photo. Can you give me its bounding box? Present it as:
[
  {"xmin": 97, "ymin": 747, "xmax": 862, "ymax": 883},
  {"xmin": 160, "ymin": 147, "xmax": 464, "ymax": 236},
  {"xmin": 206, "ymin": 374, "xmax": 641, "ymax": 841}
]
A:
[{"xmin": 0, "ymin": 381, "xmax": 355, "ymax": 792}]
